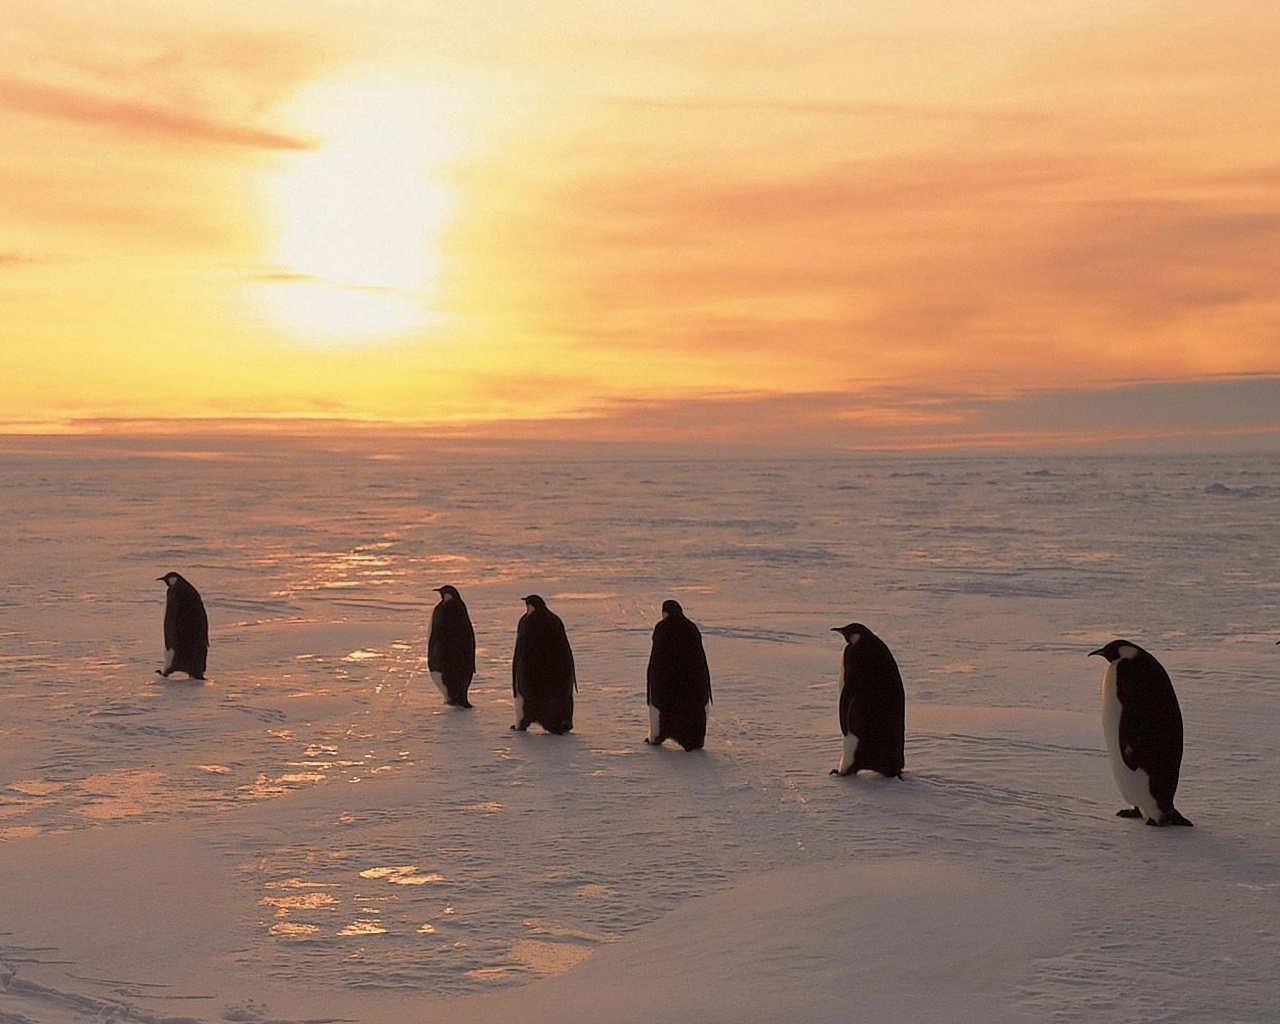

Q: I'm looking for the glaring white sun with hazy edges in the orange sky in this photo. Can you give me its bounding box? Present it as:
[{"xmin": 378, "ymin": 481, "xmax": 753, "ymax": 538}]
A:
[{"xmin": 256, "ymin": 76, "xmax": 452, "ymax": 346}]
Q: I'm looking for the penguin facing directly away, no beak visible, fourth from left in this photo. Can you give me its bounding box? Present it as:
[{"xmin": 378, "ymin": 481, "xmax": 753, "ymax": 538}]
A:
[{"xmin": 645, "ymin": 600, "xmax": 712, "ymax": 750}]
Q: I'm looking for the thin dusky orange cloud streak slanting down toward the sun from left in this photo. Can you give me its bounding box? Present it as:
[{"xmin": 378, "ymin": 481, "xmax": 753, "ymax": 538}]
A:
[{"xmin": 0, "ymin": 77, "xmax": 312, "ymax": 150}]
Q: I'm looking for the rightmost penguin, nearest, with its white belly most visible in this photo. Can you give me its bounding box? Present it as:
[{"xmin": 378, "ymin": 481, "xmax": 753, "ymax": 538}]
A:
[{"xmin": 1089, "ymin": 640, "xmax": 1190, "ymax": 826}]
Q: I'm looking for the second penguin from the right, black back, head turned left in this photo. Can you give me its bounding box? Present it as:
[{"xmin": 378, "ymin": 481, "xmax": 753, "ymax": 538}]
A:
[{"xmin": 831, "ymin": 622, "xmax": 906, "ymax": 778}]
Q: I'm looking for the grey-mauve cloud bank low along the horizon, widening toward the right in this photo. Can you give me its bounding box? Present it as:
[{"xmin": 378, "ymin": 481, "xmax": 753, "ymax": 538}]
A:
[{"xmin": 437, "ymin": 376, "xmax": 1280, "ymax": 449}]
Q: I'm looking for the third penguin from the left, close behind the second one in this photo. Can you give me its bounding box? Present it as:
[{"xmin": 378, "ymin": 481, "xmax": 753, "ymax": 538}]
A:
[{"xmin": 511, "ymin": 594, "xmax": 577, "ymax": 735}]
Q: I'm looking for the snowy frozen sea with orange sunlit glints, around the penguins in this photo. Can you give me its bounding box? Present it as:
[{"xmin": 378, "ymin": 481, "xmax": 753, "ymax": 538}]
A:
[{"xmin": 0, "ymin": 435, "xmax": 1280, "ymax": 1024}]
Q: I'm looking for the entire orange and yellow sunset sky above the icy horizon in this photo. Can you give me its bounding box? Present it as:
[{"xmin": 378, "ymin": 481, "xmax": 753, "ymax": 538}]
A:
[{"xmin": 0, "ymin": 0, "xmax": 1280, "ymax": 451}]
